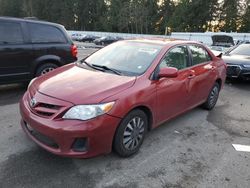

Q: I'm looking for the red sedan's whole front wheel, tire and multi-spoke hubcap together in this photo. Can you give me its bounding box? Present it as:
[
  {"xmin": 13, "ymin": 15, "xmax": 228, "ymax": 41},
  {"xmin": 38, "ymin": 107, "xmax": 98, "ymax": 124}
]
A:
[{"xmin": 113, "ymin": 110, "xmax": 148, "ymax": 157}]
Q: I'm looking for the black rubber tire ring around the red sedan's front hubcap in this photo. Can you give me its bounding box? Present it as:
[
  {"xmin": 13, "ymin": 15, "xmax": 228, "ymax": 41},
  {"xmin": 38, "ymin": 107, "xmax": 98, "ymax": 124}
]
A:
[{"xmin": 113, "ymin": 110, "xmax": 148, "ymax": 157}]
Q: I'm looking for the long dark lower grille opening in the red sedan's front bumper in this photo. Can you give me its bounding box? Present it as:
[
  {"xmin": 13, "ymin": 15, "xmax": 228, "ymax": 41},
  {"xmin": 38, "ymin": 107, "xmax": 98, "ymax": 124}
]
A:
[{"xmin": 25, "ymin": 124, "xmax": 59, "ymax": 149}]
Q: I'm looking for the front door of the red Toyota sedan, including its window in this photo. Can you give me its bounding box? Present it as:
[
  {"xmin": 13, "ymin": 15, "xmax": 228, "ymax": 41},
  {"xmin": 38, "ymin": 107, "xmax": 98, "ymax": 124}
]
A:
[{"xmin": 156, "ymin": 46, "xmax": 191, "ymax": 123}]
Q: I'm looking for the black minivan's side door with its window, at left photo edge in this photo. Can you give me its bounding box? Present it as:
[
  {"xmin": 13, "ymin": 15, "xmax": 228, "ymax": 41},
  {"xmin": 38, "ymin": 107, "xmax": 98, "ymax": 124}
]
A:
[{"xmin": 0, "ymin": 20, "xmax": 32, "ymax": 83}]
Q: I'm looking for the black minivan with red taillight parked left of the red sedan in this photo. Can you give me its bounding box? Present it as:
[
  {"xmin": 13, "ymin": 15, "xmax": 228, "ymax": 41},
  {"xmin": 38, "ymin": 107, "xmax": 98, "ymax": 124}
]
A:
[{"xmin": 0, "ymin": 17, "xmax": 77, "ymax": 84}]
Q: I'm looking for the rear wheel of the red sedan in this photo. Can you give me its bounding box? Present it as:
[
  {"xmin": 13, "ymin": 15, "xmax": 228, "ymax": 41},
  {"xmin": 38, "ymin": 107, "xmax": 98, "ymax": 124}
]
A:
[{"xmin": 202, "ymin": 82, "xmax": 220, "ymax": 110}]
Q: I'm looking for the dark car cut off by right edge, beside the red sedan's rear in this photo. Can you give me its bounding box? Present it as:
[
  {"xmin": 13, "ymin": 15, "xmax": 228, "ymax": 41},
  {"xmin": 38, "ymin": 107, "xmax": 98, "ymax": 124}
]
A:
[{"xmin": 223, "ymin": 43, "xmax": 250, "ymax": 80}]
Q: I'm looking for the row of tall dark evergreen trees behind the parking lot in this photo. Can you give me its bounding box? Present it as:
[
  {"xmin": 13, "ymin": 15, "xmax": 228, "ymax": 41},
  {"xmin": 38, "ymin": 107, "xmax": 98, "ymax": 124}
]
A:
[{"xmin": 0, "ymin": 0, "xmax": 250, "ymax": 34}]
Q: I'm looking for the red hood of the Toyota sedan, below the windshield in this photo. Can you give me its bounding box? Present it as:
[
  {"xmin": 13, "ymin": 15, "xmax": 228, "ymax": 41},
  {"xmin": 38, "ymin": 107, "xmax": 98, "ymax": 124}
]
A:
[{"xmin": 30, "ymin": 64, "xmax": 136, "ymax": 104}]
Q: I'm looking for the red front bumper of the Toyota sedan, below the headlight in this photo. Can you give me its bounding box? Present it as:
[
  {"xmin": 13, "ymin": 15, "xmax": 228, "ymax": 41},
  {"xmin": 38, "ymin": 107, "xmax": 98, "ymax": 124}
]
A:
[{"xmin": 20, "ymin": 92, "xmax": 120, "ymax": 158}]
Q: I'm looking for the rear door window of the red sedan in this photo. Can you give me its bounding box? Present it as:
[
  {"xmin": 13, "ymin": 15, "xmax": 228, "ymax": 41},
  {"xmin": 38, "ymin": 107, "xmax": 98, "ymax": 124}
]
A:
[{"xmin": 189, "ymin": 45, "xmax": 212, "ymax": 65}]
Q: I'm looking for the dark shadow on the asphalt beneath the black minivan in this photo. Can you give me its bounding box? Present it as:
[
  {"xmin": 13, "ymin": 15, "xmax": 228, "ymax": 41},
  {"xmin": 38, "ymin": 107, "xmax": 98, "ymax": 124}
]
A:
[{"xmin": 0, "ymin": 84, "xmax": 27, "ymax": 106}]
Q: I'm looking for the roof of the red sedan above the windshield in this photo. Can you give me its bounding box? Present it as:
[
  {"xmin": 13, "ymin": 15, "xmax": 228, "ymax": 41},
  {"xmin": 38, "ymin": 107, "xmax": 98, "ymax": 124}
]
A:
[{"xmin": 125, "ymin": 38, "xmax": 201, "ymax": 46}]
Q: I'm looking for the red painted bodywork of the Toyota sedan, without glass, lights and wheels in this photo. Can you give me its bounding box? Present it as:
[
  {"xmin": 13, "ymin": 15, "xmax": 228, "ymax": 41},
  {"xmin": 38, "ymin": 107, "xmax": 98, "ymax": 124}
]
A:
[{"xmin": 20, "ymin": 40, "xmax": 226, "ymax": 158}]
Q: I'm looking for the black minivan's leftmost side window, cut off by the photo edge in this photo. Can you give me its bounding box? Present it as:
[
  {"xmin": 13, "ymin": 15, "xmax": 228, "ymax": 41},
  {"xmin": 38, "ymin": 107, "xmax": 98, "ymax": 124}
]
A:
[{"xmin": 0, "ymin": 22, "xmax": 24, "ymax": 44}]
